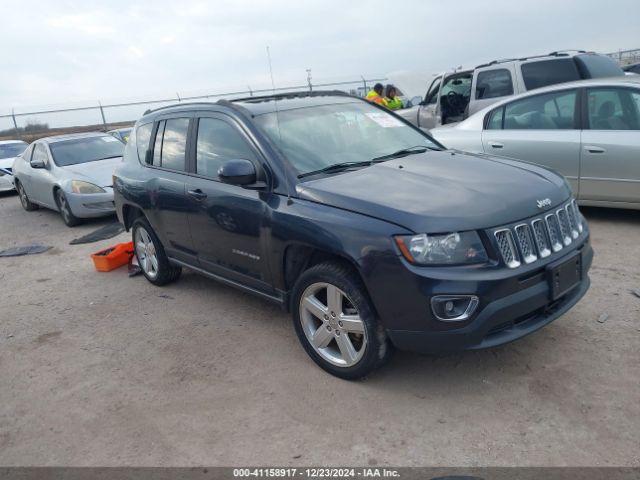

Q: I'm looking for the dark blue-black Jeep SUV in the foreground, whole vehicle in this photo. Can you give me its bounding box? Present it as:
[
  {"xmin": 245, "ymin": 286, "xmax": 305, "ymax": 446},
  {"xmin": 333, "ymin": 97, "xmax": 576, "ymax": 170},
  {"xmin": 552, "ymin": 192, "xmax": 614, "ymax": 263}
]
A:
[{"xmin": 114, "ymin": 92, "xmax": 593, "ymax": 379}]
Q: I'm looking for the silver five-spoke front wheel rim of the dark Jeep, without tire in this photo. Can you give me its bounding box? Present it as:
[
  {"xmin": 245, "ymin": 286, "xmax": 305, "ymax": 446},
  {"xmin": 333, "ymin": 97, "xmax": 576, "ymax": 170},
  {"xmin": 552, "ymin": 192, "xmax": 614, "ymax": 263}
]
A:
[{"xmin": 300, "ymin": 283, "xmax": 367, "ymax": 367}]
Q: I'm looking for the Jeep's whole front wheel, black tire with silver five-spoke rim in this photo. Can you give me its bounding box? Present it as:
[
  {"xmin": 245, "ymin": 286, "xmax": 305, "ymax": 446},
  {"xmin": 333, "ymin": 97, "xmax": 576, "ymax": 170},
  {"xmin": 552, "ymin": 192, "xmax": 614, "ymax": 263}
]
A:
[{"xmin": 292, "ymin": 262, "xmax": 391, "ymax": 380}]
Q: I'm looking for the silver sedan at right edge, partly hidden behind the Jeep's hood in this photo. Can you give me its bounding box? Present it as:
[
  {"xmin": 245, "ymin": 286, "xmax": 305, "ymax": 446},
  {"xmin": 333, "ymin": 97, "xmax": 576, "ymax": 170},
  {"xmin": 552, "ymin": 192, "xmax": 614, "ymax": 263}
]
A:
[{"xmin": 430, "ymin": 76, "xmax": 640, "ymax": 209}]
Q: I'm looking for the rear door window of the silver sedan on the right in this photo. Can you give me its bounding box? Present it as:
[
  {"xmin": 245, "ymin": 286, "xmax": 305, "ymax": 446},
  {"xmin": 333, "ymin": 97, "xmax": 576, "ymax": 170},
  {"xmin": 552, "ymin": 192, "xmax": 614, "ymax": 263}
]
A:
[{"xmin": 503, "ymin": 90, "xmax": 576, "ymax": 130}]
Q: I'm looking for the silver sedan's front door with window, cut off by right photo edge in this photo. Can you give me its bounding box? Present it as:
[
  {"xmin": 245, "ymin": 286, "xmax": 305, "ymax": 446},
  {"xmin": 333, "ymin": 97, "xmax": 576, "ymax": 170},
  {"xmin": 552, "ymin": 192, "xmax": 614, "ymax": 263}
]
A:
[{"xmin": 580, "ymin": 87, "xmax": 640, "ymax": 203}]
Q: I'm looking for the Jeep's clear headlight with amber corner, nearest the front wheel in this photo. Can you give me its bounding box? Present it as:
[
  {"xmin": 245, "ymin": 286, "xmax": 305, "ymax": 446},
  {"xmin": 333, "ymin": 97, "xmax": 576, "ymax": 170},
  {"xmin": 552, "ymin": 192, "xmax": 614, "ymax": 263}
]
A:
[{"xmin": 394, "ymin": 232, "xmax": 488, "ymax": 265}]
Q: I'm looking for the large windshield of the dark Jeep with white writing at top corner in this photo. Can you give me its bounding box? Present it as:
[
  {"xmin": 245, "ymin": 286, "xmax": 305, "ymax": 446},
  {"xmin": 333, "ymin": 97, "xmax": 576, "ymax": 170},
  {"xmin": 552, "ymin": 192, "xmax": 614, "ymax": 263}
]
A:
[{"xmin": 256, "ymin": 101, "xmax": 441, "ymax": 174}]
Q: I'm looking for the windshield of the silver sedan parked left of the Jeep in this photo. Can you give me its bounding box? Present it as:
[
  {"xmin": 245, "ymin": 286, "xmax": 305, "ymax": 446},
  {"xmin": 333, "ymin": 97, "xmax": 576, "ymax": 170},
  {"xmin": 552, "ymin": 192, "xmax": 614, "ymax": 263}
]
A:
[{"xmin": 49, "ymin": 135, "xmax": 124, "ymax": 167}]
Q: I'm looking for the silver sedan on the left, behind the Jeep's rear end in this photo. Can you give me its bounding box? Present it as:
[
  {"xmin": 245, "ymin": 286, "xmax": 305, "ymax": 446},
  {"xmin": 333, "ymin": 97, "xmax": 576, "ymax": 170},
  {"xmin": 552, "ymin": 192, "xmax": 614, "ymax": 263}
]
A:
[{"xmin": 13, "ymin": 133, "xmax": 124, "ymax": 227}]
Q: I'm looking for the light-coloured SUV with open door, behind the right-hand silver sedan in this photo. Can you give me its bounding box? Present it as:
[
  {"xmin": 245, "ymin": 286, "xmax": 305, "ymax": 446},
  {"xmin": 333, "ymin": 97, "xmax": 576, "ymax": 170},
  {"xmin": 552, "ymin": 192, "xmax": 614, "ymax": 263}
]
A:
[{"xmin": 397, "ymin": 50, "xmax": 624, "ymax": 130}]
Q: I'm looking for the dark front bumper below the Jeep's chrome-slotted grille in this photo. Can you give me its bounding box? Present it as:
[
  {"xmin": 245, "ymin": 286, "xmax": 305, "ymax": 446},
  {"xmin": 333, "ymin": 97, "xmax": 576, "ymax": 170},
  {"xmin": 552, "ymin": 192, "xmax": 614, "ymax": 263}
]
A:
[{"xmin": 372, "ymin": 236, "xmax": 593, "ymax": 354}]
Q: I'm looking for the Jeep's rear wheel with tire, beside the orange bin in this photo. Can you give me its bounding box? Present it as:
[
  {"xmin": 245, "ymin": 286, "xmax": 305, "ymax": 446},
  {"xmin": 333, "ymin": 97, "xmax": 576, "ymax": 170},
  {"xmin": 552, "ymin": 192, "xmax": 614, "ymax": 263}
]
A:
[{"xmin": 131, "ymin": 217, "xmax": 182, "ymax": 286}]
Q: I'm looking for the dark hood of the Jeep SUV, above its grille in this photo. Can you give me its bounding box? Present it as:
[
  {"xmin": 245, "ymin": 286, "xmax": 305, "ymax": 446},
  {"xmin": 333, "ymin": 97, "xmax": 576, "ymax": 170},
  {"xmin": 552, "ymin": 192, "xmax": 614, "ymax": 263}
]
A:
[{"xmin": 298, "ymin": 151, "xmax": 571, "ymax": 233}]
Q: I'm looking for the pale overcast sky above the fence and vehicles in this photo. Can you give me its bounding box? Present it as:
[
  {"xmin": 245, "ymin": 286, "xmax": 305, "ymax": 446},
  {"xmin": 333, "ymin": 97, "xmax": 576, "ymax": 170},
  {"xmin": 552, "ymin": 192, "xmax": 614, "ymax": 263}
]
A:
[{"xmin": 0, "ymin": 0, "xmax": 640, "ymax": 111}]
